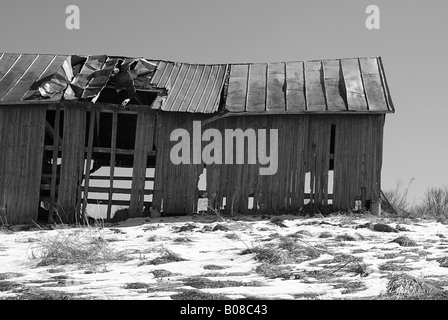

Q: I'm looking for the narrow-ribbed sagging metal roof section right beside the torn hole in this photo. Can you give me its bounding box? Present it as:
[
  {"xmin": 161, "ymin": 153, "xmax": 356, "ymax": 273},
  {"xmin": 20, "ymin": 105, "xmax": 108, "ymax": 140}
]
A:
[{"xmin": 151, "ymin": 61, "xmax": 227, "ymax": 113}]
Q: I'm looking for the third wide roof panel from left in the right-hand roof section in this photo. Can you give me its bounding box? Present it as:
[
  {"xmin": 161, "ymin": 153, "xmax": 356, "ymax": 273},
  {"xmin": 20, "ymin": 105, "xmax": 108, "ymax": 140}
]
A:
[{"xmin": 266, "ymin": 63, "xmax": 286, "ymax": 111}]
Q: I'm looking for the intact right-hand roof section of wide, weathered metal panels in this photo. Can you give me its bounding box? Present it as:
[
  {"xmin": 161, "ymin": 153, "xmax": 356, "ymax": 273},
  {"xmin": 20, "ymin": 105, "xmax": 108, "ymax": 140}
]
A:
[{"xmin": 225, "ymin": 58, "xmax": 395, "ymax": 113}]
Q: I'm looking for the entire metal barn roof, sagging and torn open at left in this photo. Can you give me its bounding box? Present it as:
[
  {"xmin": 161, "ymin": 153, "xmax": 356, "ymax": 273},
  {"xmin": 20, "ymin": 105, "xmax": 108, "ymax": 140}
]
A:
[{"xmin": 0, "ymin": 53, "xmax": 394, "ymax": 114}]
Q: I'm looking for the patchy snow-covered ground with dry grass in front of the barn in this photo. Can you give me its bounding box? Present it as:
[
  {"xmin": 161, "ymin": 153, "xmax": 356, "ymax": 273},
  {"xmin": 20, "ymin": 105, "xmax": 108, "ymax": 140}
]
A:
[{"xmin": 0, "ymin": 215, "xmax": 448, "ymax": 299}]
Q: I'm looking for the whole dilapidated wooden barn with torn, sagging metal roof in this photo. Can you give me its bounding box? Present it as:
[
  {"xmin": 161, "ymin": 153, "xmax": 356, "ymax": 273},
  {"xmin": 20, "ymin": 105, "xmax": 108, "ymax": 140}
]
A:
[{"xmin": 0, "ymin": 53, "xmax": 394, "ymax": 224}]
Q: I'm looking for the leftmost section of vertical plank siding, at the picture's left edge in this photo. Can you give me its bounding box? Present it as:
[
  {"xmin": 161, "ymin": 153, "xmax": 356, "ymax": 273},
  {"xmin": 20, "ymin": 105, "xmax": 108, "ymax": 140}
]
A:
[{"xmin": 0, "ymin": 106, "xmax": 45, "ymax": 224}]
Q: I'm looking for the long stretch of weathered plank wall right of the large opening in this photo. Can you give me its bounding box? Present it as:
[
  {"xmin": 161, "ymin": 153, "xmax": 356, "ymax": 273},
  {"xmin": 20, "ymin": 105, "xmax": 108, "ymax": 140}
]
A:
[{"xmin": 153, "ymin": 113, "xmax": 384, "ymax": 214}]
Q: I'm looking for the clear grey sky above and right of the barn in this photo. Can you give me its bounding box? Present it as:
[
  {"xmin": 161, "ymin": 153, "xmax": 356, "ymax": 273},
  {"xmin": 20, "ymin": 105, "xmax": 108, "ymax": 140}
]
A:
[{"xmin": 0, "ymin": 0, "xmax": 448, "ymax": 201}]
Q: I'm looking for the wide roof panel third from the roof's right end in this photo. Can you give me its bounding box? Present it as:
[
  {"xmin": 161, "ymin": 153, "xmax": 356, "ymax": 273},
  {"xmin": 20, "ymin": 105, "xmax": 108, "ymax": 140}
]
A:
[{"xmin": 323, "ymin": 60, "xmax": 347, "ymax": 110}]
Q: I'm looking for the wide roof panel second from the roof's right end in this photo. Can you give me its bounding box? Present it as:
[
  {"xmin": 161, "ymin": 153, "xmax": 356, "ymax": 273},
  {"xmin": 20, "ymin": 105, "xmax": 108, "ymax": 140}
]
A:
[{"xmin": 341, "ymin": 59, "xmax": 368, "ymax": 111}]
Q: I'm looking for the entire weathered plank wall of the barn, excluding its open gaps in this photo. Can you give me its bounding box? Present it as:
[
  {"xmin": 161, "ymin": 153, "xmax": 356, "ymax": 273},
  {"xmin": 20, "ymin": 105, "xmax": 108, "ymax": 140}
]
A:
[{"xmin": 0, "ymin": 103, "xmax": 384, "ymax": 224}]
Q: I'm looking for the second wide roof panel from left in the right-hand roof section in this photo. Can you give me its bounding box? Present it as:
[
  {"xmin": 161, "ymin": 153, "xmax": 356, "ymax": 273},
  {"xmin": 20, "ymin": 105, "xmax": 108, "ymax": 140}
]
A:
[{"xmin": 247, "ymin": 63, "xmax": 267, "ymax": 112}]
